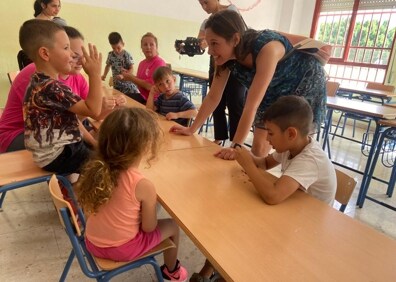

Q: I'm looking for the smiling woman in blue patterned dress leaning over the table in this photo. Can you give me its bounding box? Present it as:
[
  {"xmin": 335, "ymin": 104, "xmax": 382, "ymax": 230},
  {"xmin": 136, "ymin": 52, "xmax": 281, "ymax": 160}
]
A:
[{"xmin": 171, "ymin": 10, "xmax": 326, "ymax": 159}]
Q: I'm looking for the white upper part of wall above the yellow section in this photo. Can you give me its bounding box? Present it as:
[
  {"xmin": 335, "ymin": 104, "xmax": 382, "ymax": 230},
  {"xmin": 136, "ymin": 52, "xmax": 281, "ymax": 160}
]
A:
[{"xmin": 62, "ymin": 0, "xmax": 315, "ymax": 33}]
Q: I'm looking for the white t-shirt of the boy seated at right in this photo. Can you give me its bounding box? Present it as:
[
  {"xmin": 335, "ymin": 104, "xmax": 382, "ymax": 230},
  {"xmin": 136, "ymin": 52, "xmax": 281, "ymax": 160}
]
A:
[{"xmin": 272, "ymin": 138, "xmax": 337, "ymax": 205}]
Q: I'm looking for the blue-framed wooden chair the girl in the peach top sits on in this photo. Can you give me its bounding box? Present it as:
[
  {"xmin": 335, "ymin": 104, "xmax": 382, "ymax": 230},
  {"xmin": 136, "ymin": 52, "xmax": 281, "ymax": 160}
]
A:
[{"xmin": 49, "ymin": 175, "xmax": 175, "ymax": 281}]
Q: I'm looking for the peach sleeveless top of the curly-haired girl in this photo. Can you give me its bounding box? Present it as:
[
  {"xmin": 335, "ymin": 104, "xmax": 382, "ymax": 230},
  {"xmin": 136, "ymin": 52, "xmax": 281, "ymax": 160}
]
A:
[{"xmin": 85, "ymin": 168, "xmax": 143, "ymax": 248}]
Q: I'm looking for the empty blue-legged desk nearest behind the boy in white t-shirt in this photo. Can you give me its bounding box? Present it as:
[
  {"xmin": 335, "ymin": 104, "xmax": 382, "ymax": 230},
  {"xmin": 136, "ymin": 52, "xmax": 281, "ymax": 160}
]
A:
[{"xmin": 323, "ymin": 97, "xmax": 396, "ymax": 207}]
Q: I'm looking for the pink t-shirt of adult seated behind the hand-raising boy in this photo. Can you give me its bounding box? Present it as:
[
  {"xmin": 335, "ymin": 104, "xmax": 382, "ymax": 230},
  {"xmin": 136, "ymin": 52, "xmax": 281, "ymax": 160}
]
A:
[{"xmin": 0, "ymin": 64, "xmax": 89, "ymax": 153}]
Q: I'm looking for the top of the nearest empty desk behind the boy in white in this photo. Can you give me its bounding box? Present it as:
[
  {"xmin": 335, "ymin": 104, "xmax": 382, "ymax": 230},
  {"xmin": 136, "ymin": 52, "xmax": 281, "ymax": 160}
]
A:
[{"xmin": 326, "ymin": 97, "xmax": 396, "ymax": 119}]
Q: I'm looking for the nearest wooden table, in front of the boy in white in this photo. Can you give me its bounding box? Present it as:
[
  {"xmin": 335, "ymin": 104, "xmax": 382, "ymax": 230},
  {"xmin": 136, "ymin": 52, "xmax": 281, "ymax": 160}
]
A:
[{"xmin": 142, "ymin": 147, "xmax": 396, "ymax": 282}]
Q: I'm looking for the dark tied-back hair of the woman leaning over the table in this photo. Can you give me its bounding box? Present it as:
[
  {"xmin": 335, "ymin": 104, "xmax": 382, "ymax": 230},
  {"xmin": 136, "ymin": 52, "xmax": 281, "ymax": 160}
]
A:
[{"xmin": 205, "ymin": 9, "xmax": 258, "ymax": 70}]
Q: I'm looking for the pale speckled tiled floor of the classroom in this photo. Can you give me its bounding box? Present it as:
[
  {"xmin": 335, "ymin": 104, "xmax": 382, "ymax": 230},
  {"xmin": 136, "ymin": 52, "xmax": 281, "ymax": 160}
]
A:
[{"xmin": 0, "ymin": 119, "xmax": 396, "ymax": 281}]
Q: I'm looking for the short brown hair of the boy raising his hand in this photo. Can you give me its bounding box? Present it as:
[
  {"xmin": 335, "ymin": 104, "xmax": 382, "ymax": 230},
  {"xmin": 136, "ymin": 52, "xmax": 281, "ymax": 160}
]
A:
[{"xmin": 19, "ymin": 19, "xmax": 64, "ymax": 61}]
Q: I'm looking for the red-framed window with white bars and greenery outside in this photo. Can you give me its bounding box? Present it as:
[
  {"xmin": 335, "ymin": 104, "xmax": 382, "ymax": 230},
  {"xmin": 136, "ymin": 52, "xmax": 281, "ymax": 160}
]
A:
[{"xmin": 311, "ymin": 0, "xmax": 396, "ymax": 86}]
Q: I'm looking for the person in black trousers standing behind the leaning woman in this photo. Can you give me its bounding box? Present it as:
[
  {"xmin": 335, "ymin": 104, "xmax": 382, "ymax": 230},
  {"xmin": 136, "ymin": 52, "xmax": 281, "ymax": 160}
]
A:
[{"xmin": 198, "ymin": 0, "xmax": 246, "ymax": 145}]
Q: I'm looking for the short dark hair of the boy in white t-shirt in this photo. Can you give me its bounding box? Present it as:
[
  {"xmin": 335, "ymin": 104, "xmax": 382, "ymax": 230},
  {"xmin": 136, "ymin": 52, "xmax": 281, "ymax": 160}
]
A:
[{"xmin": 263, "ymin": 95, "xmax": 313, "ymax": 136}]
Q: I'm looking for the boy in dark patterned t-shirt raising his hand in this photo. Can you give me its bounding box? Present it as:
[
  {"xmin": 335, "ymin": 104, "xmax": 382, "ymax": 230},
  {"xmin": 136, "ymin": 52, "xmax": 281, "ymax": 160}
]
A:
[{"xmin": 19, "ymin": 19, "xmax": 103, "ymax": 173}]
